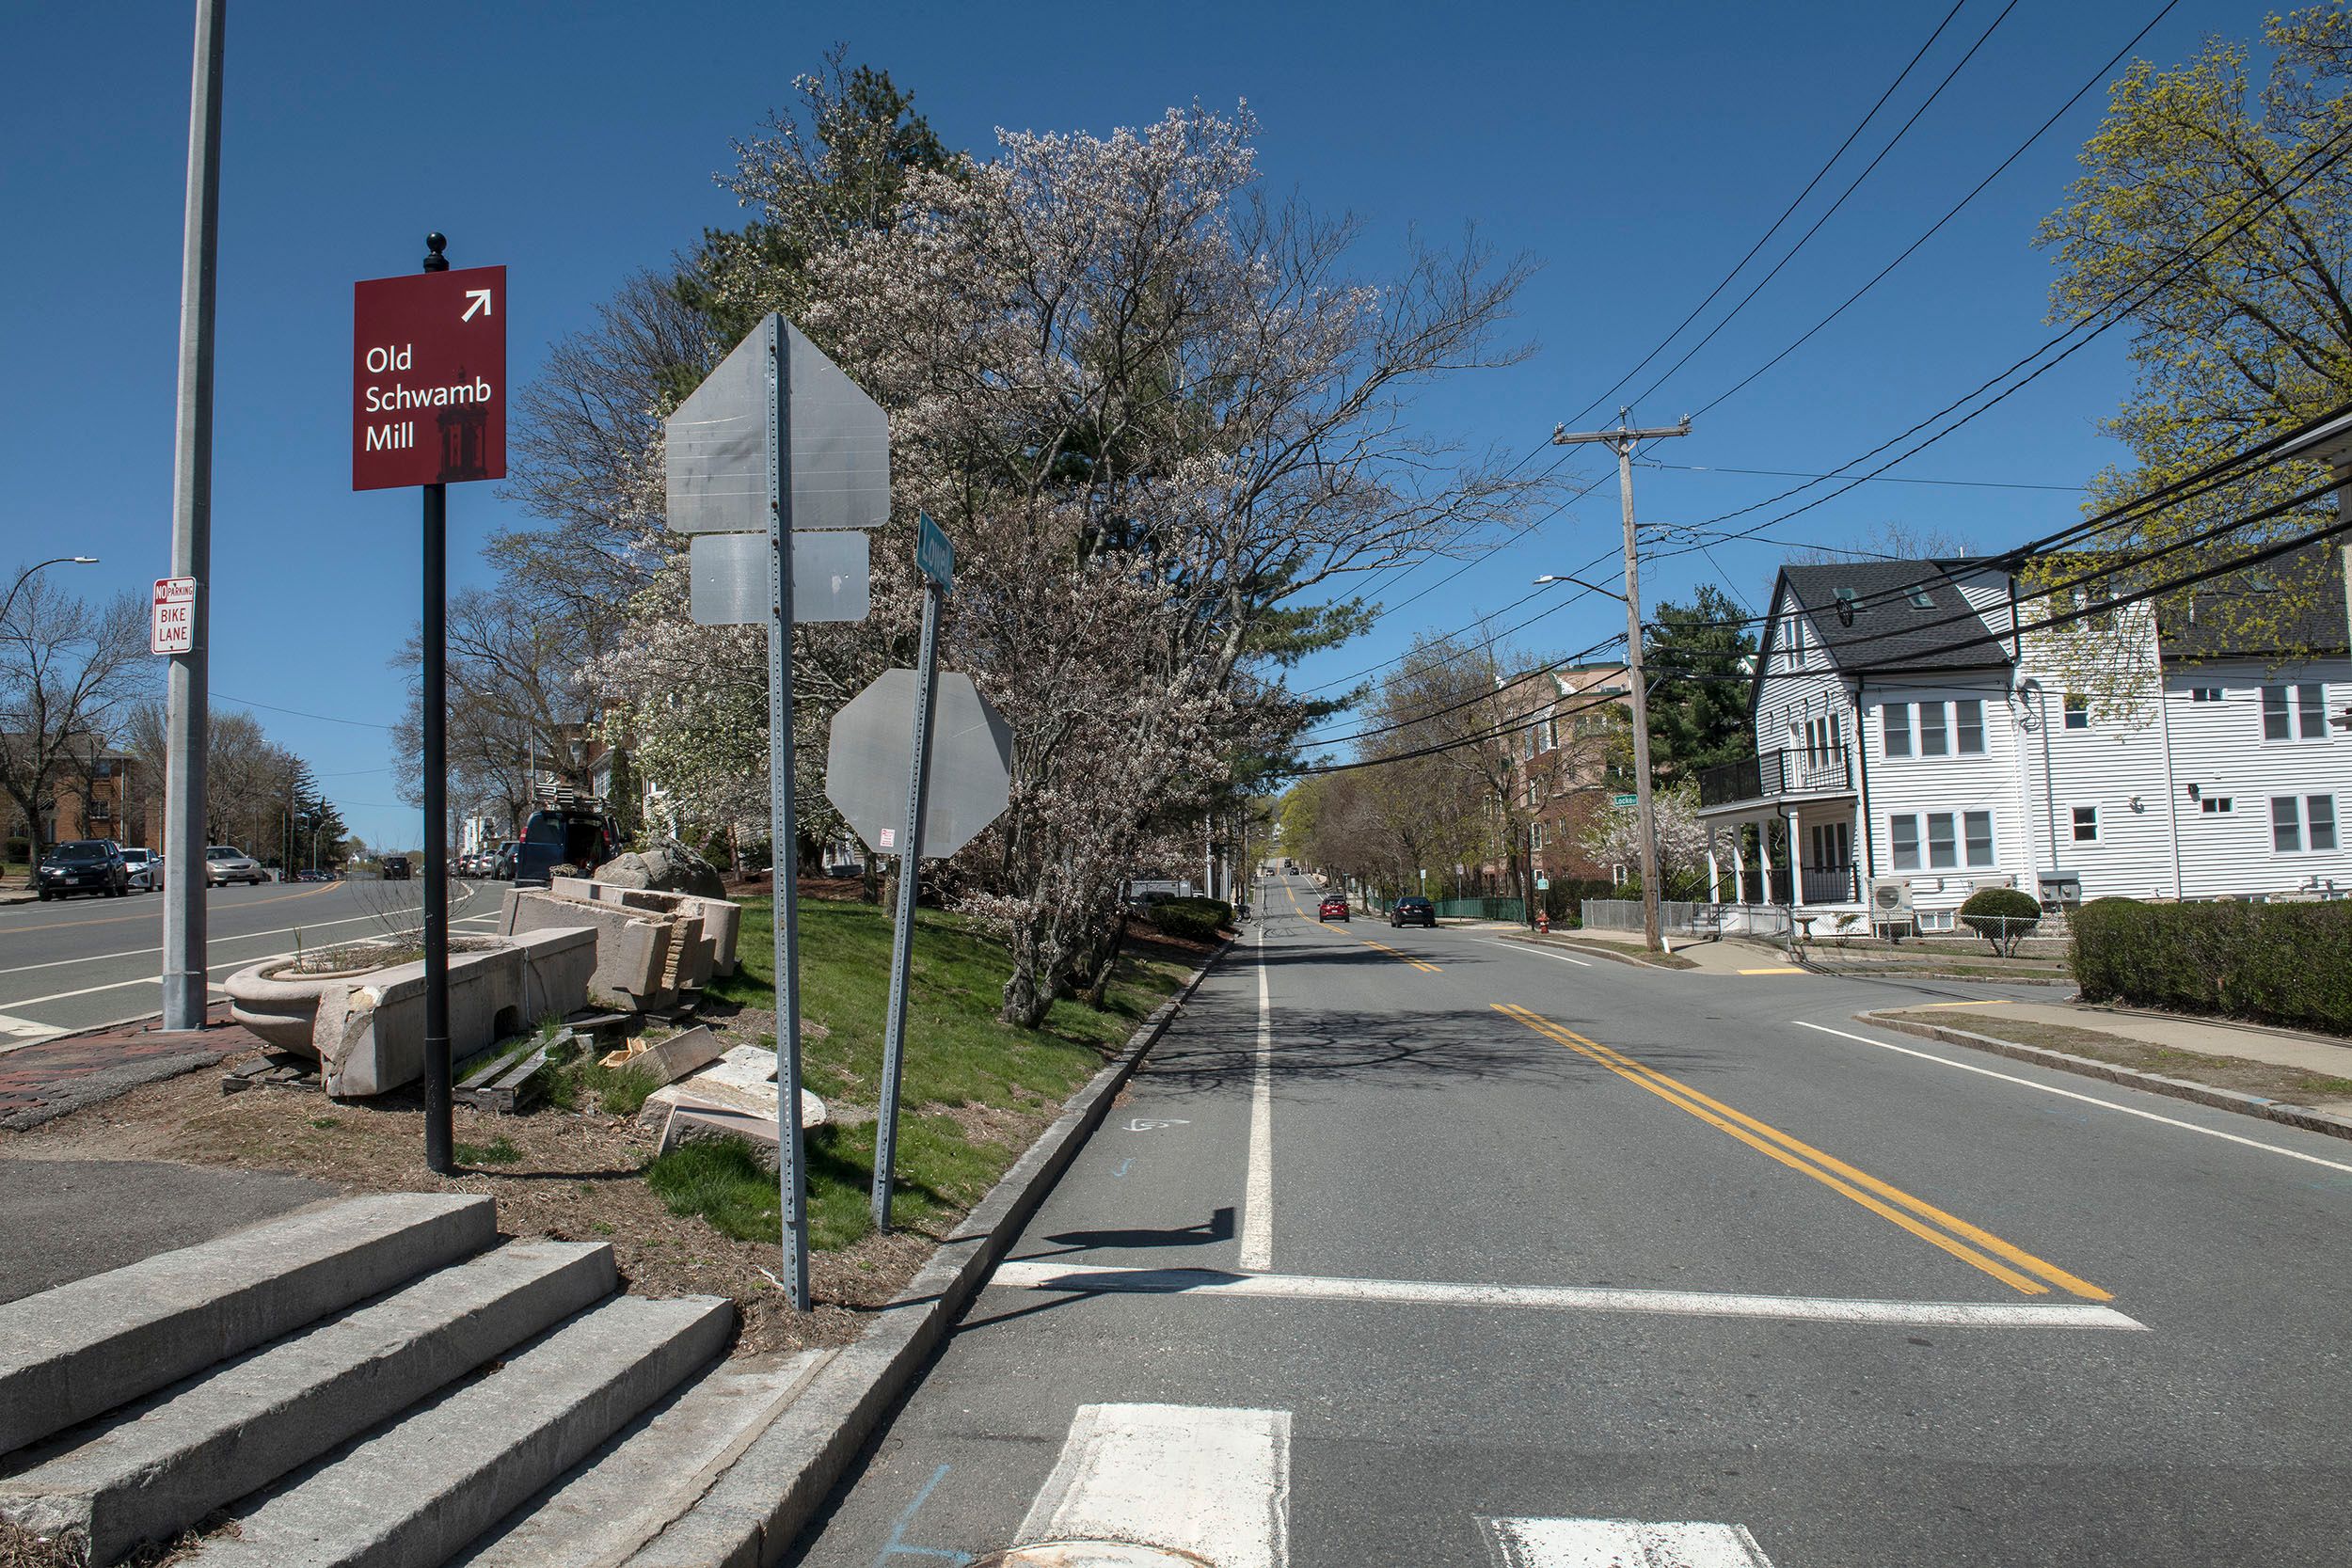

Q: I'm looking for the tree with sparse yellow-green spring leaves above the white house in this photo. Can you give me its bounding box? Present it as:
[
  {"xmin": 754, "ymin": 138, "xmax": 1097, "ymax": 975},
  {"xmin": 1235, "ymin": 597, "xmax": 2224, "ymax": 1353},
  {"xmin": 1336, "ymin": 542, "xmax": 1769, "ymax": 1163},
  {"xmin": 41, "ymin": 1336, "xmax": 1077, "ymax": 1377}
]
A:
[{"xmin": 2027, "ymin": 5, "xmax": 2352, "ymax": 681}]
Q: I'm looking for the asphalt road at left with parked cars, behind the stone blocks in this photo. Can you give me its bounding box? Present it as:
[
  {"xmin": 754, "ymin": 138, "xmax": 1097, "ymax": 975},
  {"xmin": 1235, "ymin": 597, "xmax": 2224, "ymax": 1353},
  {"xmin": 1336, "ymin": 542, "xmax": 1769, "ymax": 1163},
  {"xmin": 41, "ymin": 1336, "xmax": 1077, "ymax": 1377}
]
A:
[{"xmin": 0, "ymin": 881, "xmax": 503, "ymax": 1051}]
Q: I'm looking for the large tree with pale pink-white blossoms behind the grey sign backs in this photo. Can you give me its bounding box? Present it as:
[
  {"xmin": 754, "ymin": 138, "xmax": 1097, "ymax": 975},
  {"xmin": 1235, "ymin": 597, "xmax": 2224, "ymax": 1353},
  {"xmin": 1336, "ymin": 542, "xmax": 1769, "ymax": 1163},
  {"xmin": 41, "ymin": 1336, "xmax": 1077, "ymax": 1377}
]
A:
[{"xmin": 548, "ymin": 77, "xmax": 1548, "ymax": 1025}]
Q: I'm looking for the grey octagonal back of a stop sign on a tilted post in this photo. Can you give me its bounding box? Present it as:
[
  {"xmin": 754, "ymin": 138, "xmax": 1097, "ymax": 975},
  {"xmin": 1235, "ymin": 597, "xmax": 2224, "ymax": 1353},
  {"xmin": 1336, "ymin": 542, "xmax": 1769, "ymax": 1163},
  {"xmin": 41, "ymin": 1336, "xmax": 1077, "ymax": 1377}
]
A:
[{"xmin": 826, "ymin": 670, "xmax": 1014, "ymax": 861}]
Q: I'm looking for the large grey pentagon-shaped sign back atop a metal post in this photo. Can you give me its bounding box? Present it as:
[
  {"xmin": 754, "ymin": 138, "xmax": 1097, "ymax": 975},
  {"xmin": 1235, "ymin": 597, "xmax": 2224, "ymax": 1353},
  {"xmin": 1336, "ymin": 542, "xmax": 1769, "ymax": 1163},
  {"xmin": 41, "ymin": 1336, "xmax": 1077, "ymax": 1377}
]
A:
[{"xmin": 663, "ymin": 315, "xmax": 889, "ymax": 533}]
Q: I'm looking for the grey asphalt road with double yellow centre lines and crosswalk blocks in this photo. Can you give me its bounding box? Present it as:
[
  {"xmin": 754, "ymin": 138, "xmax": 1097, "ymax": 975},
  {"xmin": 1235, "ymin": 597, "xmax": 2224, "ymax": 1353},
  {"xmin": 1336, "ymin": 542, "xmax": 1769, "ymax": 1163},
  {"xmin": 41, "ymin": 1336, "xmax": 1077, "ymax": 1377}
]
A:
[{"xmin": 795, "ymin": 884, "xmax": 2352, "ymax": 1568}]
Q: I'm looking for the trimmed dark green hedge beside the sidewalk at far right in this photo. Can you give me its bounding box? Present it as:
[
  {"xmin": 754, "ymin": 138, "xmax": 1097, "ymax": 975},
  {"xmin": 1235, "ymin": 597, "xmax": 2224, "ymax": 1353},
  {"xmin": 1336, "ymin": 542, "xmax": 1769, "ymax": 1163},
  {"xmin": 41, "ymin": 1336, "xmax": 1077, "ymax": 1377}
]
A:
[{"xmin": 2070, "ymin": 898, "xmax": 2352, "ymax": 1035}]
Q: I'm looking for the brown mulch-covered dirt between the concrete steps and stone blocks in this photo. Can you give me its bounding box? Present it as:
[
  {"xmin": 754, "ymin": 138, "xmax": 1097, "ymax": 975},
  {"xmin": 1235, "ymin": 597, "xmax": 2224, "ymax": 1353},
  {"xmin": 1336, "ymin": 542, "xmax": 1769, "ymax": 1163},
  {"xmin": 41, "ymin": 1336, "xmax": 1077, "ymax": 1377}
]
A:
[{"xmin": 0, "ymin": 1013, "xmax": 950, "ymax": 1354}]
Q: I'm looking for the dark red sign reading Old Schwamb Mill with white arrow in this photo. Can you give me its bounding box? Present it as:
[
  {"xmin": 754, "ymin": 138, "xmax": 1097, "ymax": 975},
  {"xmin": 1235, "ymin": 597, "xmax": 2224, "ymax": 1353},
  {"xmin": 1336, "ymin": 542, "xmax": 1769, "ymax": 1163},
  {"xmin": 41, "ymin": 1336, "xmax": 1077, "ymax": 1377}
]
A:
[{"xmin": 351, "ymin": 265, "xmax": 506, "ymax": 489}]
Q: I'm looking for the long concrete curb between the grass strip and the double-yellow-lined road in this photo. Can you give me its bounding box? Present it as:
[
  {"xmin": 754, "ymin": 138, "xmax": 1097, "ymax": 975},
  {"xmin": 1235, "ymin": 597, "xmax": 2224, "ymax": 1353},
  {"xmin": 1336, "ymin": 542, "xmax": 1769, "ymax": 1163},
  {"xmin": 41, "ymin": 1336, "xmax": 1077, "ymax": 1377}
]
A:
[{"xmin": 628, "ymin": 941, "xmax": 1232, "ymax": 1568}]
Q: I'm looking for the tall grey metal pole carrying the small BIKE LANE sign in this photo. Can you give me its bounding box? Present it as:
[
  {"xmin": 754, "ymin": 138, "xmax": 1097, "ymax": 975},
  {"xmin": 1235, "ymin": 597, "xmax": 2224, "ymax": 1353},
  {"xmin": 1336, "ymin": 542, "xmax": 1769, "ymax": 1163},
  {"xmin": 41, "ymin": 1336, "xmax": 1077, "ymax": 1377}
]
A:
[{"xmin": 163, "ymin": 0, "xmax": 229, "ymax": 1030}]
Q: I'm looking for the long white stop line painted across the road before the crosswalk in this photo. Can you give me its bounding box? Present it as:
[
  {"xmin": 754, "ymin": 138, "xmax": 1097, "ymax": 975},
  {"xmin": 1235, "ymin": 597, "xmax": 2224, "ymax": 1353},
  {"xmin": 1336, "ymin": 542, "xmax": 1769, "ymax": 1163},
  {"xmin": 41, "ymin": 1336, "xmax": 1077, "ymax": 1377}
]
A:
[{"xmin": 995, "ymin": 1260, "xmax": 2148, "ymax": 1333}]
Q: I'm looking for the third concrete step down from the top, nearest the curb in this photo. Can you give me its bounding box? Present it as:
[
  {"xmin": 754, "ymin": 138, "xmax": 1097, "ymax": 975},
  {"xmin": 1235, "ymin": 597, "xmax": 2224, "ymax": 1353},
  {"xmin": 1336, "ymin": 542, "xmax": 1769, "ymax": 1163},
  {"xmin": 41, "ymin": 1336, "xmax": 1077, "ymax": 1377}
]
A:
[{"xmin": 188, "ymin": 1295, "xmax": 734, "ymax": 1568}]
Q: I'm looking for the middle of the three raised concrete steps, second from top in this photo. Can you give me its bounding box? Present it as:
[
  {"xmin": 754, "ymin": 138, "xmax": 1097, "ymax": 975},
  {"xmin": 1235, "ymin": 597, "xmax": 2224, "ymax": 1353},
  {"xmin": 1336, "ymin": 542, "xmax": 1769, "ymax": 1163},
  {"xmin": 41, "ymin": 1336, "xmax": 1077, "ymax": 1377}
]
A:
[{"xmin": 0, "ymin": 1242, "xmax": 619, "ymax": 1563}]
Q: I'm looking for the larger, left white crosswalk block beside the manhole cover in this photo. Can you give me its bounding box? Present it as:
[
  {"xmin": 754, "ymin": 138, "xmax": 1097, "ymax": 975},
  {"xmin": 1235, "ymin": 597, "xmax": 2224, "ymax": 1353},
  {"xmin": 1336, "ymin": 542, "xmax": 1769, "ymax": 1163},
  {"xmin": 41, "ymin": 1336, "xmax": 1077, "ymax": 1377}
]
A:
[{"xmin": 1019, "ymin": 1406, "xmax": 1292, "ymax": 1568}]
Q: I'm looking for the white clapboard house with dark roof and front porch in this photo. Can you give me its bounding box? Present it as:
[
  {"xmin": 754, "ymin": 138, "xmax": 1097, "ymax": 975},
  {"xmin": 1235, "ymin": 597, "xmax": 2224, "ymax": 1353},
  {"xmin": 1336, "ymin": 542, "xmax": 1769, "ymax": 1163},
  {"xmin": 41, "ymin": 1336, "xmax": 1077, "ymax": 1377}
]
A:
[{"xmin": 1701, "ymin": 547, "xmax": 2352, "ymax": 931}]
